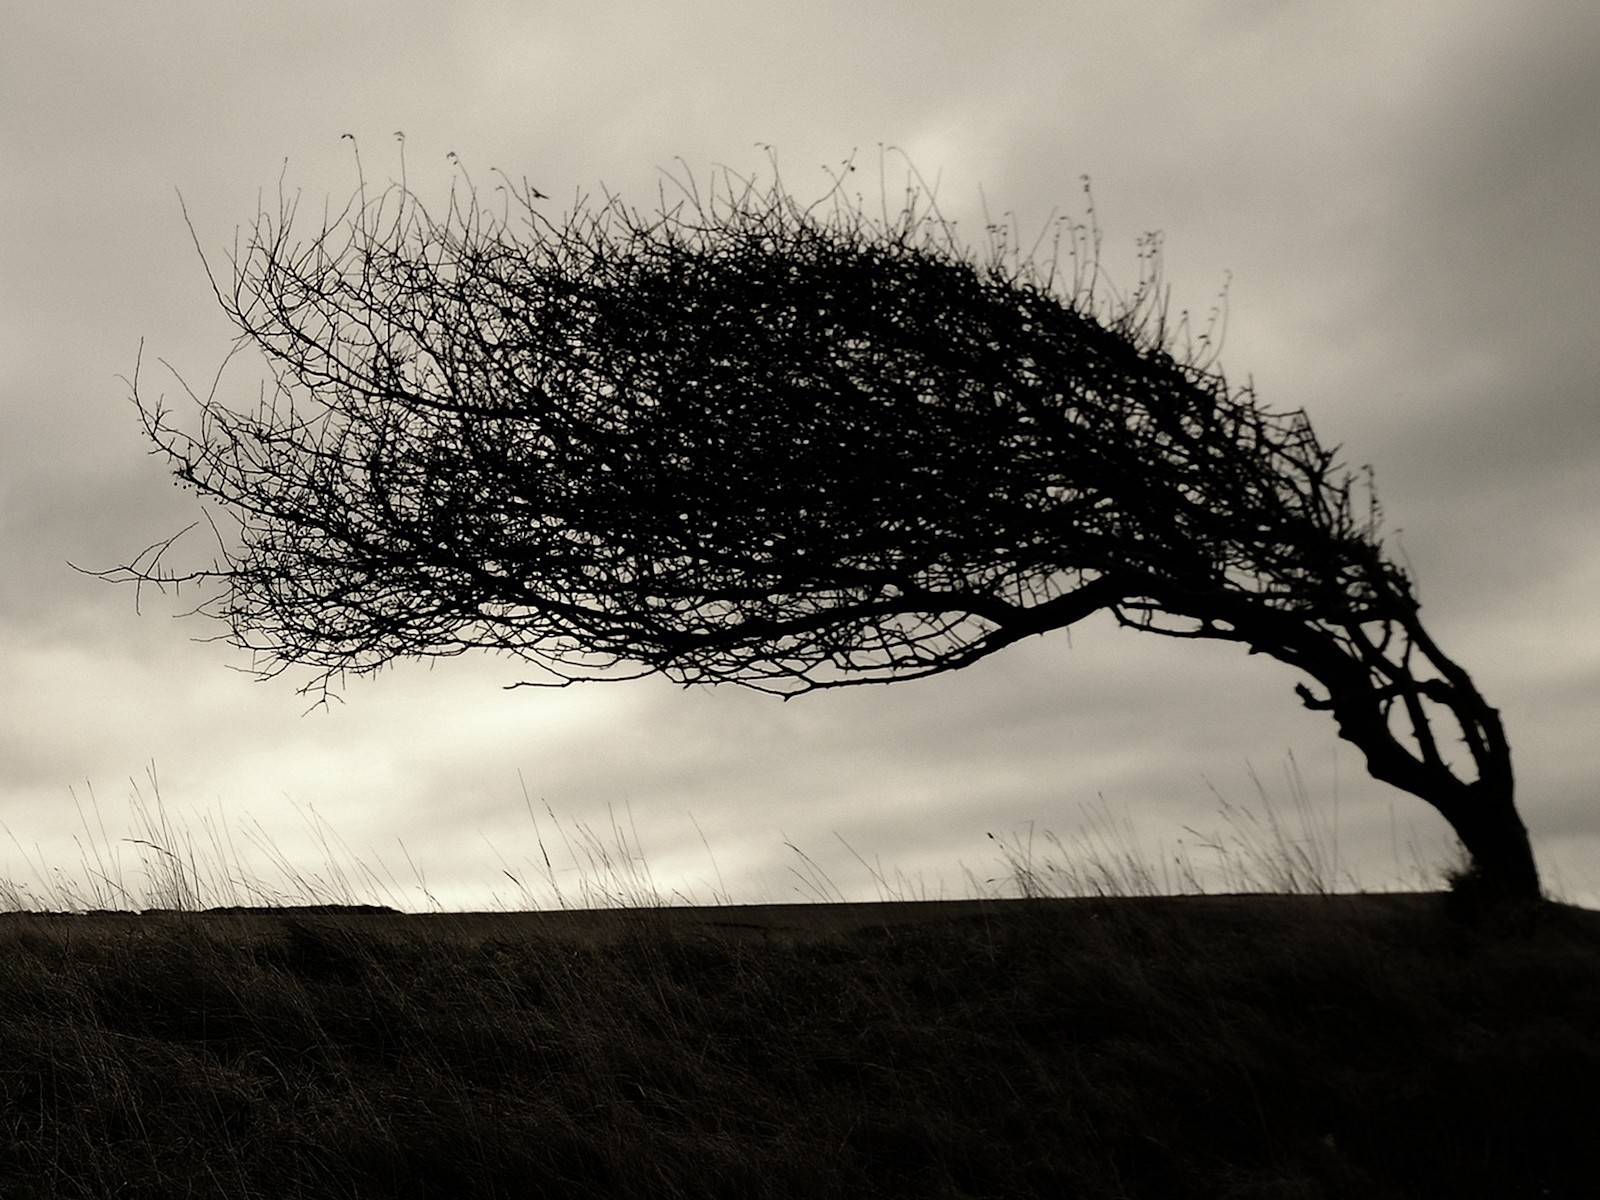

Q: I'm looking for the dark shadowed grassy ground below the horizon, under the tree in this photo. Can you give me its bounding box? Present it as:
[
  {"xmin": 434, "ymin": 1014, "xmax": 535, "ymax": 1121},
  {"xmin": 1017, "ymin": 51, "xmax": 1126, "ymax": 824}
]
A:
[{"xmin": 0, "ymin": 894, "xmax": 1600, "ymax": 1200}]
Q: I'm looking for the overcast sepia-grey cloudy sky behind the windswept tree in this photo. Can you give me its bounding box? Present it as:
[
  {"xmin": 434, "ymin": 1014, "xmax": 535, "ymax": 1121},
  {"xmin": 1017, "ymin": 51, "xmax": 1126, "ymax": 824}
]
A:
[{"xmin": 0, "ymin": 0, "xmax": 1600, "ymax": 909}]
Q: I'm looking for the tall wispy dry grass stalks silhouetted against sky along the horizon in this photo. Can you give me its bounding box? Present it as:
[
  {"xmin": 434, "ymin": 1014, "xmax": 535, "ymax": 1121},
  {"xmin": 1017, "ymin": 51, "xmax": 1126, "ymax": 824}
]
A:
[{"xmin": 0, "ymin": 755, "xmax": 1459, "ymax": 912}]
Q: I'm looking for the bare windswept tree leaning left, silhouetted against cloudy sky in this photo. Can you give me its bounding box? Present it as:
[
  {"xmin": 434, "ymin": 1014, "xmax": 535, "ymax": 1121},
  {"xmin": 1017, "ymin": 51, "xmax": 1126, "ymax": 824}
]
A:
[{"xmin": 109, "ymin": 157, "xmax": 1539, "ymax": 899}]
